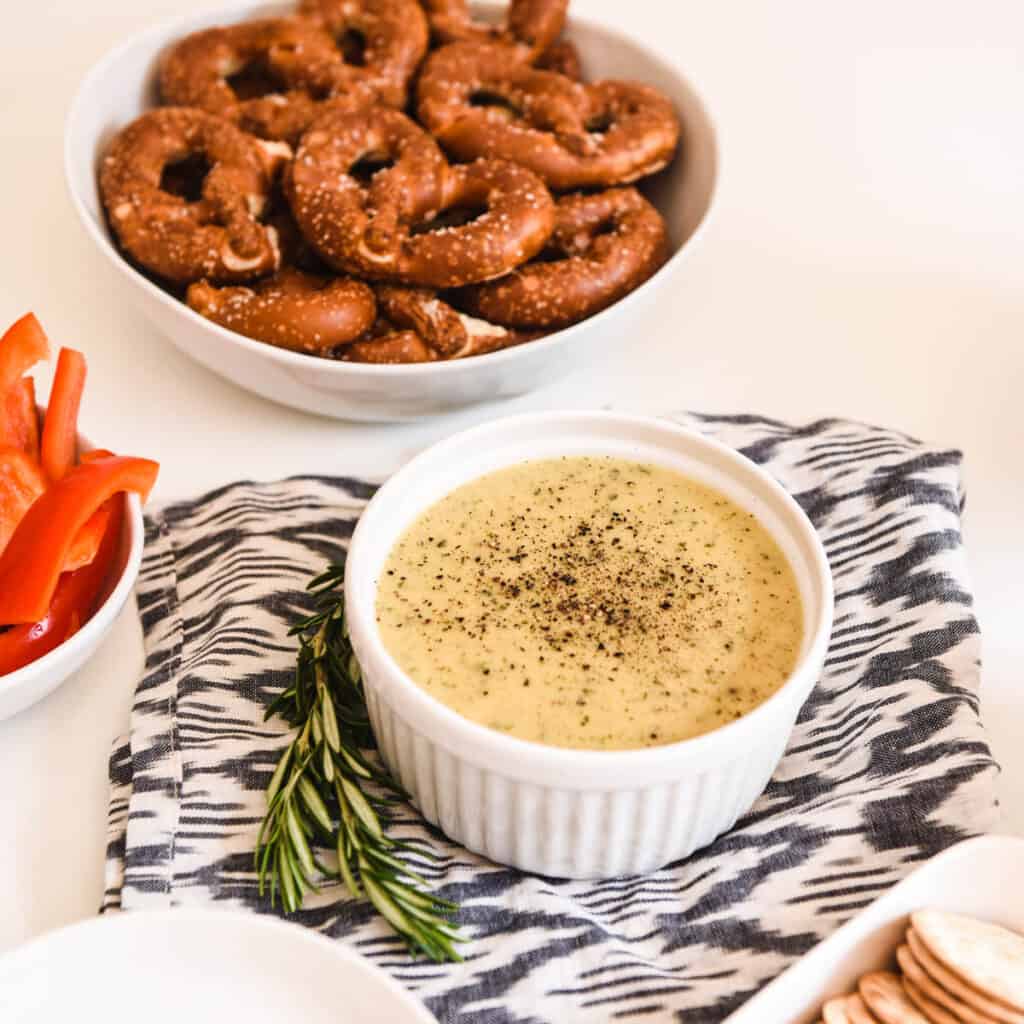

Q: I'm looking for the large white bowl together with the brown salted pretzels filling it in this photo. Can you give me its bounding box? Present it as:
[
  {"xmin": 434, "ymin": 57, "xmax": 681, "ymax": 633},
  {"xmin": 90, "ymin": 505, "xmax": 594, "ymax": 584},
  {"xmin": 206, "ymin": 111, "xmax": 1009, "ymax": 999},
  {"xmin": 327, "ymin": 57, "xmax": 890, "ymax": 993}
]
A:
[{"xmin": 65, "ymin": 0, "xmax": 717, "ymax": 421}]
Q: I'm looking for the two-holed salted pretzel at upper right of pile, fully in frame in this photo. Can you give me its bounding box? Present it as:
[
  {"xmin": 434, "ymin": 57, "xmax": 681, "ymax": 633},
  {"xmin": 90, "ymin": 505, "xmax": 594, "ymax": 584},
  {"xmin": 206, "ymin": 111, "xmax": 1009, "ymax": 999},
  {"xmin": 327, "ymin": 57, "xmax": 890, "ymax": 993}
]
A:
[{"xmin": 418, "ymin": 43, "xmax": 679, "ymax": 190}]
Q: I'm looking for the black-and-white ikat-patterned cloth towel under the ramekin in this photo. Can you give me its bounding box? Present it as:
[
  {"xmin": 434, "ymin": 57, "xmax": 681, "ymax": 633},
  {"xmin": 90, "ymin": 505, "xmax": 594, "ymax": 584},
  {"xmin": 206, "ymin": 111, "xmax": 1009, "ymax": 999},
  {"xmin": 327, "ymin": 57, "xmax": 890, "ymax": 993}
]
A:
[{"xmin": 103, "ymin": 415, "xmax": 997, "ymax": 1024}]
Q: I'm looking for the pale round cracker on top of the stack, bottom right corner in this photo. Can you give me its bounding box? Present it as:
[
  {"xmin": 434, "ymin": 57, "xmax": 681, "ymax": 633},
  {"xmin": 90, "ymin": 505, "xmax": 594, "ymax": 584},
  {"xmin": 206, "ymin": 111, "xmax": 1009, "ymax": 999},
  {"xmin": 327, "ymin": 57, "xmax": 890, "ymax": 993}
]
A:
[{"xmin": 910, "ymin": 910, "xmax": 1024, "ymax": 1013}]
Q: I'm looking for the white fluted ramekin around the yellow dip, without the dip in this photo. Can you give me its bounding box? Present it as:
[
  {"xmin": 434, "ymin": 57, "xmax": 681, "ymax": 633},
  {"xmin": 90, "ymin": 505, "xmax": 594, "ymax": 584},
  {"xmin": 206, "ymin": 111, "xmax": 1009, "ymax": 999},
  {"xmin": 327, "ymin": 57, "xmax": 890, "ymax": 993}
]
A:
[{"xmin": 345, "ymin": 413, "xmax": 833, "ymax": 878}]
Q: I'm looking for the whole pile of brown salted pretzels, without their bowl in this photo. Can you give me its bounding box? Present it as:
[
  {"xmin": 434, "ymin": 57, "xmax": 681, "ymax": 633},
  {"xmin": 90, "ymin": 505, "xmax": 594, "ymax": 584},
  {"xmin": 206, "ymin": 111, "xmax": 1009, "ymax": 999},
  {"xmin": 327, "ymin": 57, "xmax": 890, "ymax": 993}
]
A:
[{"xmin": 99, "ymin": 0, "xmax": 679, "ymax": 362}]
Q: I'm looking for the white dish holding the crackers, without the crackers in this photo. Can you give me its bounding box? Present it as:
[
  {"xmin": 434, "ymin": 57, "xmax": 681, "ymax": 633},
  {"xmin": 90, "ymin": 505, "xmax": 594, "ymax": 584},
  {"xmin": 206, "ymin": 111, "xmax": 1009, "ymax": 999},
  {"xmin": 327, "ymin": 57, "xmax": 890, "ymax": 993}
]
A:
[{"xmin": 725, "ymin": 836, "xmax": 1024, "ymax": 1024}]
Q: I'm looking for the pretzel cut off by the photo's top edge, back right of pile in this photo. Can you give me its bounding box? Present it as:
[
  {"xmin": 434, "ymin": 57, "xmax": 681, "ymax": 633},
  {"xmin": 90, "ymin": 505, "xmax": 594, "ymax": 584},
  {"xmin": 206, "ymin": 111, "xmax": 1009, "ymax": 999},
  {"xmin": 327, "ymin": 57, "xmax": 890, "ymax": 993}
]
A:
[{"xmin": 423, "ymin": 0, "xmax": 569, "ymax": 62}]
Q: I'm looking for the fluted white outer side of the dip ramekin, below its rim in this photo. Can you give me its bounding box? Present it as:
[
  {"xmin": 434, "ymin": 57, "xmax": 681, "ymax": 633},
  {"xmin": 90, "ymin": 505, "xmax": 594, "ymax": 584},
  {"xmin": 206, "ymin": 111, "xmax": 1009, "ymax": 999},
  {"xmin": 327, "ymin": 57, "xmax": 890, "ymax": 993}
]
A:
[{"xmin": 367, "ymin": 688, "xmax": 799, "ymax": 879}]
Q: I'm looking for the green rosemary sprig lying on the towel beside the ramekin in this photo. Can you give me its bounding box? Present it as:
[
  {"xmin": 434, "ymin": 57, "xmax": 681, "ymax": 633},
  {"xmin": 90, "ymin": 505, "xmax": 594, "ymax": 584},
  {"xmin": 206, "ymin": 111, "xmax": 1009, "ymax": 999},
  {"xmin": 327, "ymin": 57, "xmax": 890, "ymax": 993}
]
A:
[{"xmin": 256, "ymin": 562, "xmax": 463, "ymax": 961}]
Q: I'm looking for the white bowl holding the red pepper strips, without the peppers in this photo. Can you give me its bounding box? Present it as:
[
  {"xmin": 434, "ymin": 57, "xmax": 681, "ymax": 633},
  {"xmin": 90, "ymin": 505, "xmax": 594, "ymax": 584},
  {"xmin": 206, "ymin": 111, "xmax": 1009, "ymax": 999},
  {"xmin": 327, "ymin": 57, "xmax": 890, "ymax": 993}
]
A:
[{"xmin": 0, "ymin": 428, "xmax": 144, "ymax": 721}]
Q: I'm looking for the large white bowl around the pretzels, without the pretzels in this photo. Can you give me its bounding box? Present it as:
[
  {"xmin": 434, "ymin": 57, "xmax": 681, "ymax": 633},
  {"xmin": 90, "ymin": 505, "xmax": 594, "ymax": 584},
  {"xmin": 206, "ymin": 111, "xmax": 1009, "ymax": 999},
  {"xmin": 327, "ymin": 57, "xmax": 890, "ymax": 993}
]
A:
[{"xmin": 65, "ymin": 3, "xmax": 718, "ymax": 421}]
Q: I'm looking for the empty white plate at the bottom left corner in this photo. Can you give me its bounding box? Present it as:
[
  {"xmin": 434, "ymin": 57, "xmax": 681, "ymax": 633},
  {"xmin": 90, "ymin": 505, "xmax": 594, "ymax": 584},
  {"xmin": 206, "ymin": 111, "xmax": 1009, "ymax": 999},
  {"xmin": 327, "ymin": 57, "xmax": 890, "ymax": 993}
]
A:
[{"xmin": 0, "ymin": 909, "xmax": 436, "ymax": 1024}]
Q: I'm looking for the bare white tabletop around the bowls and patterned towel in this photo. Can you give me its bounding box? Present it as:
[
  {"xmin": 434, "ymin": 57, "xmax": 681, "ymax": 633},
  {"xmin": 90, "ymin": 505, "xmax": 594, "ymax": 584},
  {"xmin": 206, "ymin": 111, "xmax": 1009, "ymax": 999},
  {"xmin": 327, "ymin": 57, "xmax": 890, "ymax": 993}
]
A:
[{"xmin": 0, "ymin": 0, "xmax": 1024, "ymax": 949}]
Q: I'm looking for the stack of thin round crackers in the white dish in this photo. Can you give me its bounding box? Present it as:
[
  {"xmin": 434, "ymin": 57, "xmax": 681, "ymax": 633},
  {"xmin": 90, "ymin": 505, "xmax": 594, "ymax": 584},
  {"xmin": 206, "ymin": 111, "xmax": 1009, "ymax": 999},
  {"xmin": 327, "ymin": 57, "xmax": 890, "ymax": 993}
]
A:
[{"xmin": 821, "ymin": 910, "xmax": 1024, "ymax": 1024}]
